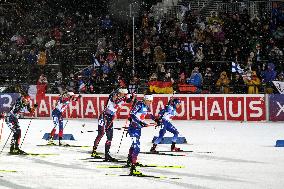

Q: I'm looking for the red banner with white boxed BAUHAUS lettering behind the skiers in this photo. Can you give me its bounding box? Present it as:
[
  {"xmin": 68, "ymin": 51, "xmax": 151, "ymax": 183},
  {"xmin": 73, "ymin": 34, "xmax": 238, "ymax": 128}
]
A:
[{"xmin": 23, "ymin": 94, "xmax": 266, "ymax": 121}]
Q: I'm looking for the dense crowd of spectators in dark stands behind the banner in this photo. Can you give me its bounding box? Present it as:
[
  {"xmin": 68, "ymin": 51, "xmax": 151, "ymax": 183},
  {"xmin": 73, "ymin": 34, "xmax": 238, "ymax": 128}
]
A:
[{"xmin": 0, "ymin": 1, "xmax": 284, "ymax": 94}]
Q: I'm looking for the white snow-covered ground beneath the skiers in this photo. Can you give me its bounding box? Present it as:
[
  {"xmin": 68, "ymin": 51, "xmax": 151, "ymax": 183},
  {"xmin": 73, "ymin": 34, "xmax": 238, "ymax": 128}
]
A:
[{"xmin": 0, "ymin": 119, "xmax": 284, "ymax": 189}]
